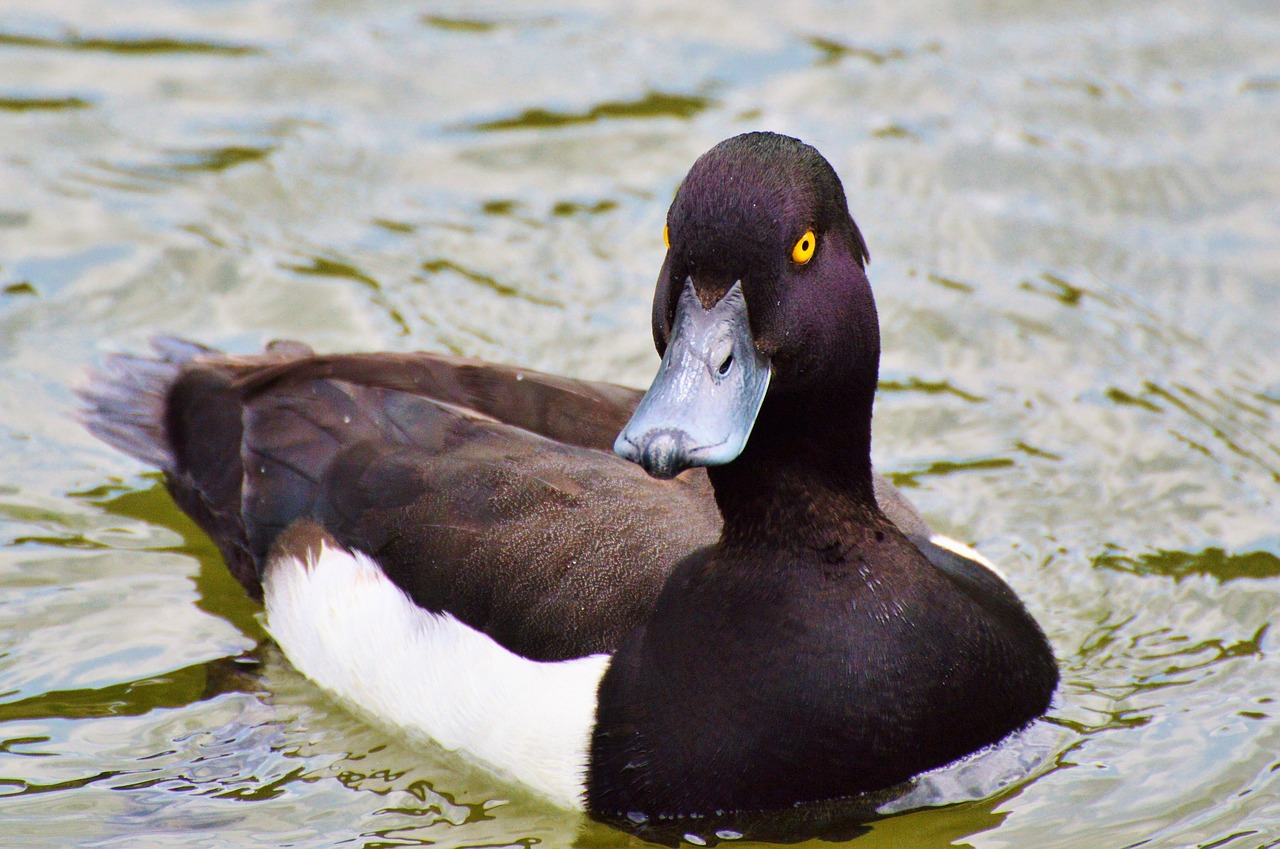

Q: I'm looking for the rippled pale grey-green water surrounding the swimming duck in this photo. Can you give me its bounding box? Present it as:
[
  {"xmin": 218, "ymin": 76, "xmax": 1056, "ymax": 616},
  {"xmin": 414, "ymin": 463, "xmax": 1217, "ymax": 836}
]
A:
[{"xmin": 0, "ymin": 0, "xmax": 1280, "ymax": 849}]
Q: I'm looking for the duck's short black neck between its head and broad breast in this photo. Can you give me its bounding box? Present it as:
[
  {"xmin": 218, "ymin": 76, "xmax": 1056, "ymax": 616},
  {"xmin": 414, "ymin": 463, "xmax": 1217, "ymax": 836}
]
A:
[{"xmin": 708, "ymin": 392, "xmax": 879, "ymax": 549}]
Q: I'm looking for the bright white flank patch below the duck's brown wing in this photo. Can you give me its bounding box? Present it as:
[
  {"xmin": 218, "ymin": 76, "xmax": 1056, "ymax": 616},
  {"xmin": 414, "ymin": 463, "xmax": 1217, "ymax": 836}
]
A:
[{"xmin": 264, "ymin": 547, "xmax": 609, "ymax": 809}]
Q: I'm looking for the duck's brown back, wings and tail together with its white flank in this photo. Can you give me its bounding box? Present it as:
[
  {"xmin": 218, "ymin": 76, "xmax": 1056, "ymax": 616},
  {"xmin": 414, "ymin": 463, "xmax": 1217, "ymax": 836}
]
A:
[{"xmin": 82, "ymin": 339, "xmax": 719, "ymax": 807}]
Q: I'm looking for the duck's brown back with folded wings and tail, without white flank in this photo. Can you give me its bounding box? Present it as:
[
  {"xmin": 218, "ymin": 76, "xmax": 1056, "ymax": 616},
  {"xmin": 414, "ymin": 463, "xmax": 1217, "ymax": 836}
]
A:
[{"xmin": 82, "ymin": 342, "xmax": 719, "ymax": 659}]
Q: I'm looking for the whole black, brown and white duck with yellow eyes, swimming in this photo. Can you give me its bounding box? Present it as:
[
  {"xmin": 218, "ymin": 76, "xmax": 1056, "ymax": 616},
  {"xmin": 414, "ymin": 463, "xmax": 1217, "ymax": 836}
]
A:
[{"xmin": 83, "ymin": 133, "xmax": 1057, "ymax": 816}]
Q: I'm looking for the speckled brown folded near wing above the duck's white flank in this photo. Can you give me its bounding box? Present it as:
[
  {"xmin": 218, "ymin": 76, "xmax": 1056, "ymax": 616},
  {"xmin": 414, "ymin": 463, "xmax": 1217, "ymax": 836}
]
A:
[{"xmin": 242, "ymin": 361, "xmax": 719, "ymax": 659}]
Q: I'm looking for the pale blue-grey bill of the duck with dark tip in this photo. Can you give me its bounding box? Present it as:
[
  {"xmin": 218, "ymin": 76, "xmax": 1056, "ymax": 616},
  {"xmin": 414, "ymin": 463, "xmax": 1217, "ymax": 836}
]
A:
[{"xmin": 613, "ymin": 279, "xmax": 769, "ymax": 479}]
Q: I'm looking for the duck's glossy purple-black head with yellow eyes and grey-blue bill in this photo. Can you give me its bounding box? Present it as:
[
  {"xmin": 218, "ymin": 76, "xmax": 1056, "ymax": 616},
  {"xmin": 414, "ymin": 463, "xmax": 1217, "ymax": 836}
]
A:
[{"xmin": 613, "ymin": 133, "xmax": 879, "ymax": 478}]
